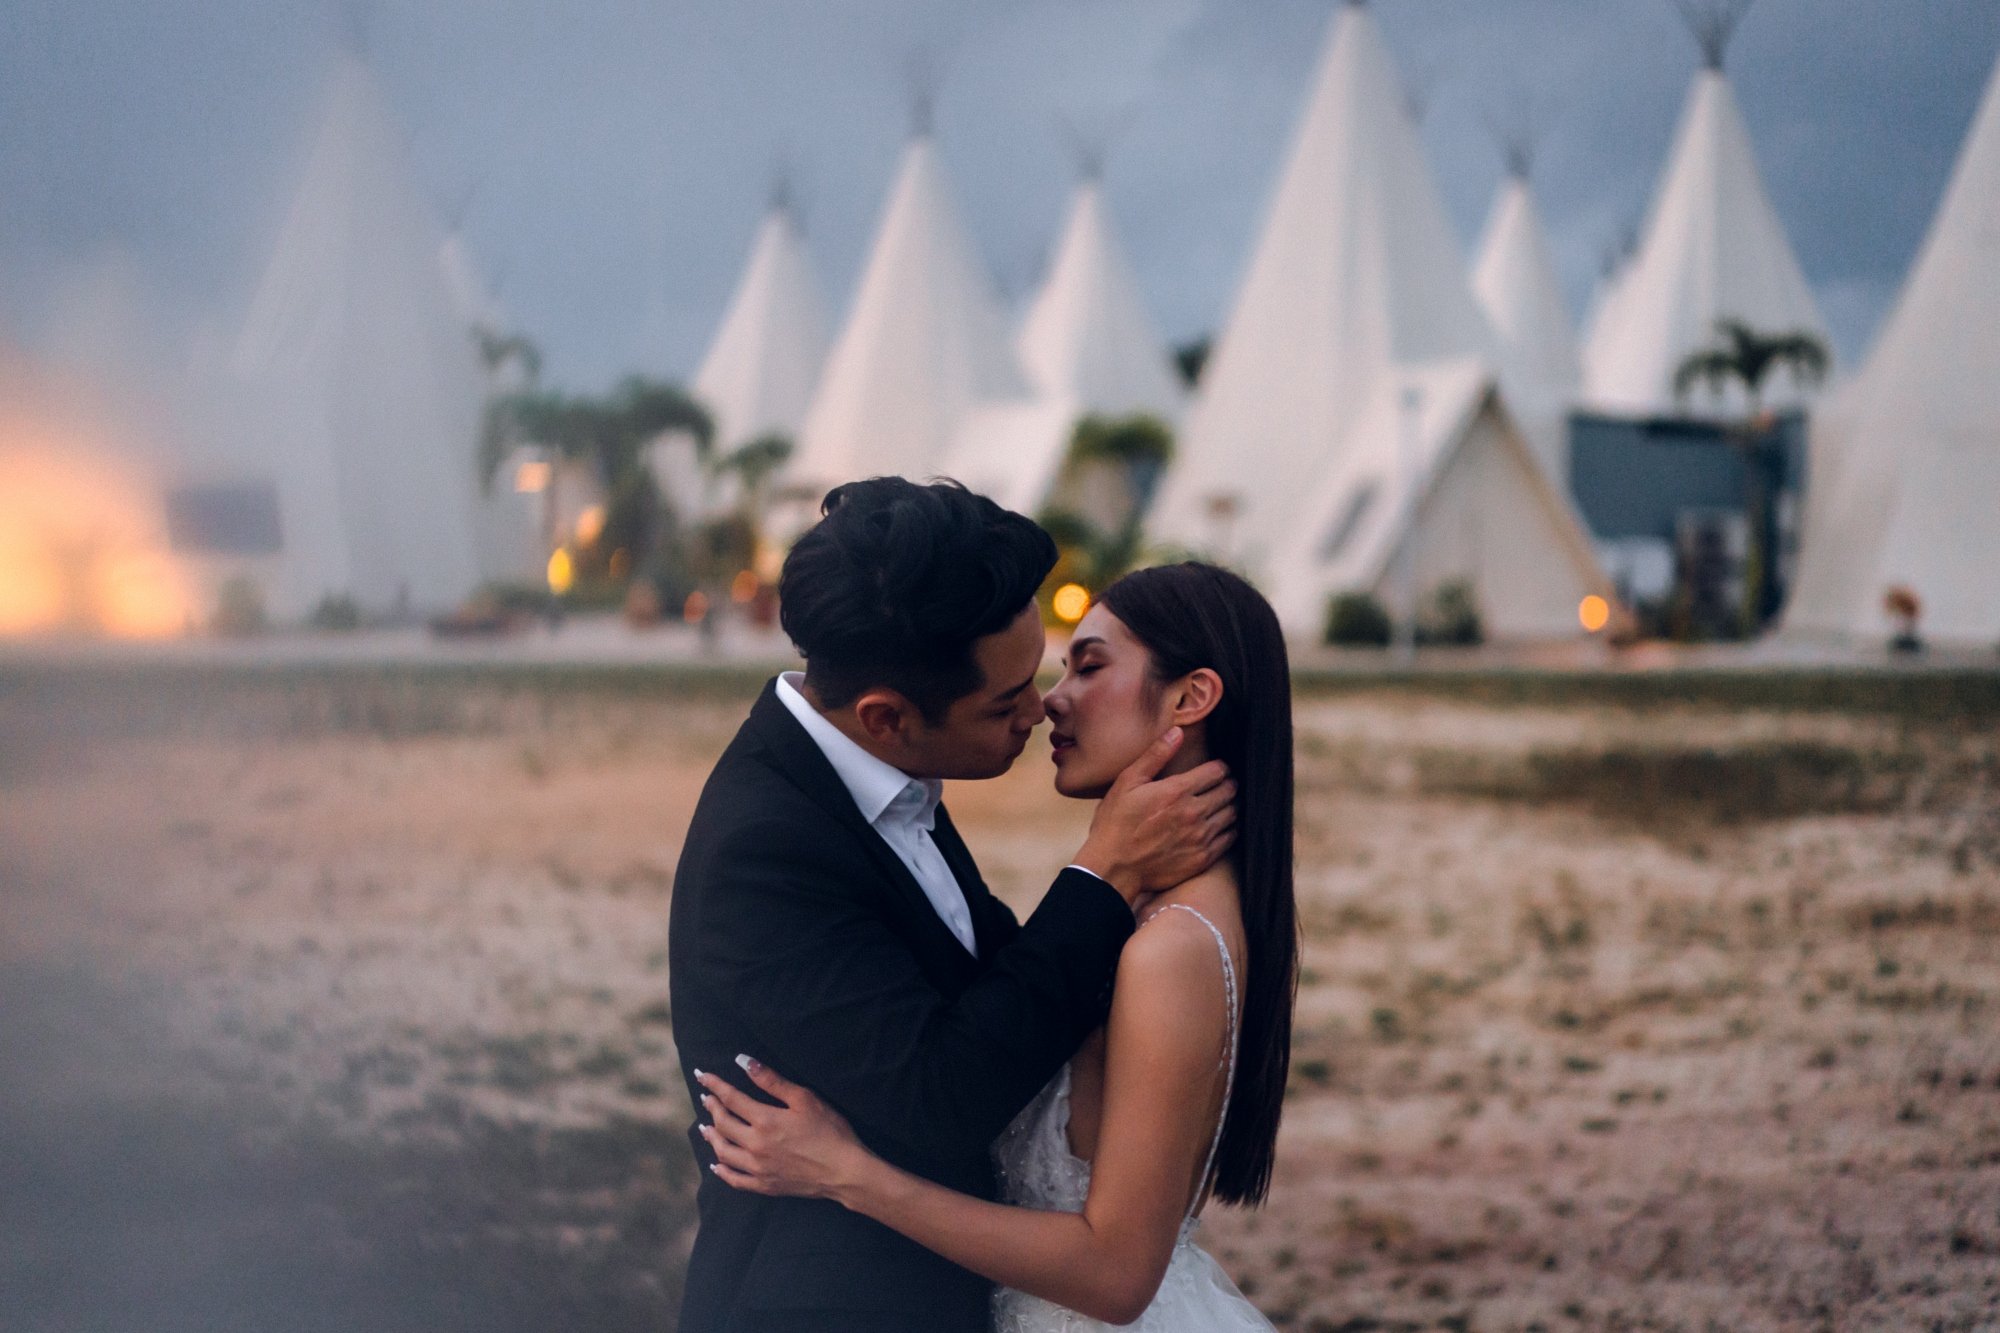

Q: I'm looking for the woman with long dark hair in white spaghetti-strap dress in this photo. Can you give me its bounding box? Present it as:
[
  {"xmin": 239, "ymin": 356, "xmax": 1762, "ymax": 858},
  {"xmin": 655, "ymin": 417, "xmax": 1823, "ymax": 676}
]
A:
[{"xmin": 702, "ymin": 564, "xmax": 1298, "ymax": 1333}]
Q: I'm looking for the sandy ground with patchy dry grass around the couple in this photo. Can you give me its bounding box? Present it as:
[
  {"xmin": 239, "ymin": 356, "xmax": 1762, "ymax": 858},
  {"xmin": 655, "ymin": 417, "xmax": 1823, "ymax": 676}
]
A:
[{"xmin": 0, "ymin": 673, "xmax": 2000, "ymax": 1333}]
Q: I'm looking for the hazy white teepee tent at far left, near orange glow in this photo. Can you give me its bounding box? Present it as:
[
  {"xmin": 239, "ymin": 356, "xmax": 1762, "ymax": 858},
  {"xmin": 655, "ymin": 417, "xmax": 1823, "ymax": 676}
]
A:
[{"xmin": 232, "ymin": 58, "xmax": 484, "ymax": 614}]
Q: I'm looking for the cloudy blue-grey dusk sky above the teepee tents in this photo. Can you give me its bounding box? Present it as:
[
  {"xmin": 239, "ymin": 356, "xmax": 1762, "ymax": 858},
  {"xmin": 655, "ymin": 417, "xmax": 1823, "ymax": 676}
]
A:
[{"xmin": 0, "ymin": 0, "xmax": 2000, "ymax": 388}]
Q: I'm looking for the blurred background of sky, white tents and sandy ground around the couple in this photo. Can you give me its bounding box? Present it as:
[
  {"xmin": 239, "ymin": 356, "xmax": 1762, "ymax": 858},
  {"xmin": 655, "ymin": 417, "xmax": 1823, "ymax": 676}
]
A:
[{"xmin": 0, "ymin": 0, "xmax": 2000, "ymax": 1329}]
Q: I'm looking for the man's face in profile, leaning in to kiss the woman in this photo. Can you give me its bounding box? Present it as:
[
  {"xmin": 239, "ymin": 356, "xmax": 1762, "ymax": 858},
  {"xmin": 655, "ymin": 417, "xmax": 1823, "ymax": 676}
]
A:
[{"xmin": 896, "ymin": 602, "xmax": 1046, "ymax": 779}]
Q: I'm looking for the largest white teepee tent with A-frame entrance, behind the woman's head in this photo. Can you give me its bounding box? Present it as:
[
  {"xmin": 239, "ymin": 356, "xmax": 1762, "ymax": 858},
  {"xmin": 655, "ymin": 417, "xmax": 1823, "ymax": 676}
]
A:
[{"xmin": 1154, "ymin": 2, "xmax": 1604, "ymax": 636}]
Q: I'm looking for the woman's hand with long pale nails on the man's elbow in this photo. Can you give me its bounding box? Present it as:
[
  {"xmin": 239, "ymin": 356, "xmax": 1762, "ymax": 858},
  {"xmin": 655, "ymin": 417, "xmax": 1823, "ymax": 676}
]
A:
[{"xmin": 694, "ymin": 1057, "xmax": 868, "ymax": 1201}]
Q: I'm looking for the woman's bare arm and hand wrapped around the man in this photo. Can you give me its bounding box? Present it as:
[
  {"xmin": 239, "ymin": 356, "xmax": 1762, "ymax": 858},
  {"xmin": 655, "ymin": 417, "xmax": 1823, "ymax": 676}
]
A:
[{"xmin": 702, "ymin": 913, "xmax": 1226, "ymax": 1323}]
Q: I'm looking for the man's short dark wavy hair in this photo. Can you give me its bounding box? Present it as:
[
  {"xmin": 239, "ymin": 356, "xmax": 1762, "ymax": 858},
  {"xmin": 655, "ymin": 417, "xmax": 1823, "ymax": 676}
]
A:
[{"xmin": 778, "ymin": 476, "xmax": 1056, "ymax": 723}]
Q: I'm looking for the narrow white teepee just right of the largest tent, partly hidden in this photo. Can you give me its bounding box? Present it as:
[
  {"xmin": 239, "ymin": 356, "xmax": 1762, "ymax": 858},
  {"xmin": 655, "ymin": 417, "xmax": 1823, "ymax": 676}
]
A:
[{"xmin": 1472, "ymin": 172, "xmax": 1582, "ymax": 484}]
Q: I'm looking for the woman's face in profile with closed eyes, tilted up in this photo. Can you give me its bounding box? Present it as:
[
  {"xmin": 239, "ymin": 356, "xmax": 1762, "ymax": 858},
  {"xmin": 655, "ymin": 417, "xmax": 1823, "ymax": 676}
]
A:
[{"xmin": 1042, "ymin": 606, "xmax": 1170, "ymax": 799}]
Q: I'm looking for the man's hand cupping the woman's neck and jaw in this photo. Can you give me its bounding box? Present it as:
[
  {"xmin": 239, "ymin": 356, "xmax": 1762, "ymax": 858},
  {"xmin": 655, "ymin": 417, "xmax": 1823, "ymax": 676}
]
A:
[{"xmin": 1074, "ymin": 727, "xmax": 1236, "ymax": 903}]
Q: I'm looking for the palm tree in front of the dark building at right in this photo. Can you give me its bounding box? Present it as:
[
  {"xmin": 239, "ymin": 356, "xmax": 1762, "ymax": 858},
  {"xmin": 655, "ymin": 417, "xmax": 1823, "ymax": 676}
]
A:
[{"xmin": 1674, "ymin": 318, "xmax": 1832, "ymax": 636}]
